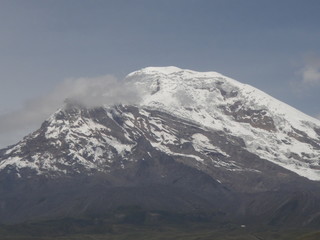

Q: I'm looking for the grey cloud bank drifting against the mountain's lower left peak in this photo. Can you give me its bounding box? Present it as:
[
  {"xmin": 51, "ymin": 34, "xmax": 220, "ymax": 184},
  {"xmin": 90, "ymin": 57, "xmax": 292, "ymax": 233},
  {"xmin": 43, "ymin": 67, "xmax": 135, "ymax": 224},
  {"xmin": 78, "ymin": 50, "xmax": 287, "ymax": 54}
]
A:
[{"xmin": 0, "ymin": 75, "xmax": 139, "ymax": 148}]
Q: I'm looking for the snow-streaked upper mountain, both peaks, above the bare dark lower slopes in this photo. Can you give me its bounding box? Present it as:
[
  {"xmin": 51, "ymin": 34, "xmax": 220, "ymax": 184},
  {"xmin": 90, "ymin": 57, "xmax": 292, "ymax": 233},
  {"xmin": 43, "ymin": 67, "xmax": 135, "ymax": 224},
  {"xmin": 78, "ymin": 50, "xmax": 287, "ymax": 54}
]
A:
[{"xmin": 0, "ymin": 67, "xmax": 320, "ymax": 180}]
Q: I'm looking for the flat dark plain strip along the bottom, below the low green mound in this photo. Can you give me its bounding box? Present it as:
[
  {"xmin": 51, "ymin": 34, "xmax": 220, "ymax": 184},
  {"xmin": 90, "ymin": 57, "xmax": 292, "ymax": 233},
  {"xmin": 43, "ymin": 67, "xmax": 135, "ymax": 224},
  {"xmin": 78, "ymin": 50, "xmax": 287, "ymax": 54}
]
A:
[{"xmin": 0, "ymin": 219, "xmax": 320, "ymax": 240}]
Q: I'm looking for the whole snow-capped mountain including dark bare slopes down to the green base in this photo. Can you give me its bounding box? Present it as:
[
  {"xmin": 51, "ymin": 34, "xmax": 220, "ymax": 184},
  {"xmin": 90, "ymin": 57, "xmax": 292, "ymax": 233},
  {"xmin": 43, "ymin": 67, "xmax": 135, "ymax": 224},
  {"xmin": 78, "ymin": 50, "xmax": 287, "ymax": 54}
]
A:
[{"xmin": 0, "ymin": 67, "xmax": 320, "ymax": 226}]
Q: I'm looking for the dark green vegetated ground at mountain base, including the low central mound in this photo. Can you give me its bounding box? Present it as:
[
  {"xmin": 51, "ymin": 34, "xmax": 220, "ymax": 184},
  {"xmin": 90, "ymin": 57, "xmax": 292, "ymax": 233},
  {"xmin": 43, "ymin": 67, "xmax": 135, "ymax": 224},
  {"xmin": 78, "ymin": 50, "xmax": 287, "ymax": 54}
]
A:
[{"xmin": 0, "ymin": 206, "xmax": 320, "ymax": 240}]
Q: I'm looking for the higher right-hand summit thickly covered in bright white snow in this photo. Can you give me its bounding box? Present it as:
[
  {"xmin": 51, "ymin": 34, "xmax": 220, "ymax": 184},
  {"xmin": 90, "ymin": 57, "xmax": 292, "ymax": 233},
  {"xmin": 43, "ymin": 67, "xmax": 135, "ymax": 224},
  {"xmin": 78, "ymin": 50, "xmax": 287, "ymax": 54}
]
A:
[{"xmin": 127, "ymin": 67, "xmax": 320, "ymax": 180}]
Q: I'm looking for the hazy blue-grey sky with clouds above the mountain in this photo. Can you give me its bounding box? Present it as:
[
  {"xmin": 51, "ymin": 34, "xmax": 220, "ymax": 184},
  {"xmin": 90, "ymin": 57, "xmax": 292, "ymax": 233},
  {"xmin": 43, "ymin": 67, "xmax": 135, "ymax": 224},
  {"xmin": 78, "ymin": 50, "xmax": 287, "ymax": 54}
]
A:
[{"xmin": 0, "ymin": 0, "xmax": 320, "ymax": 148}]
